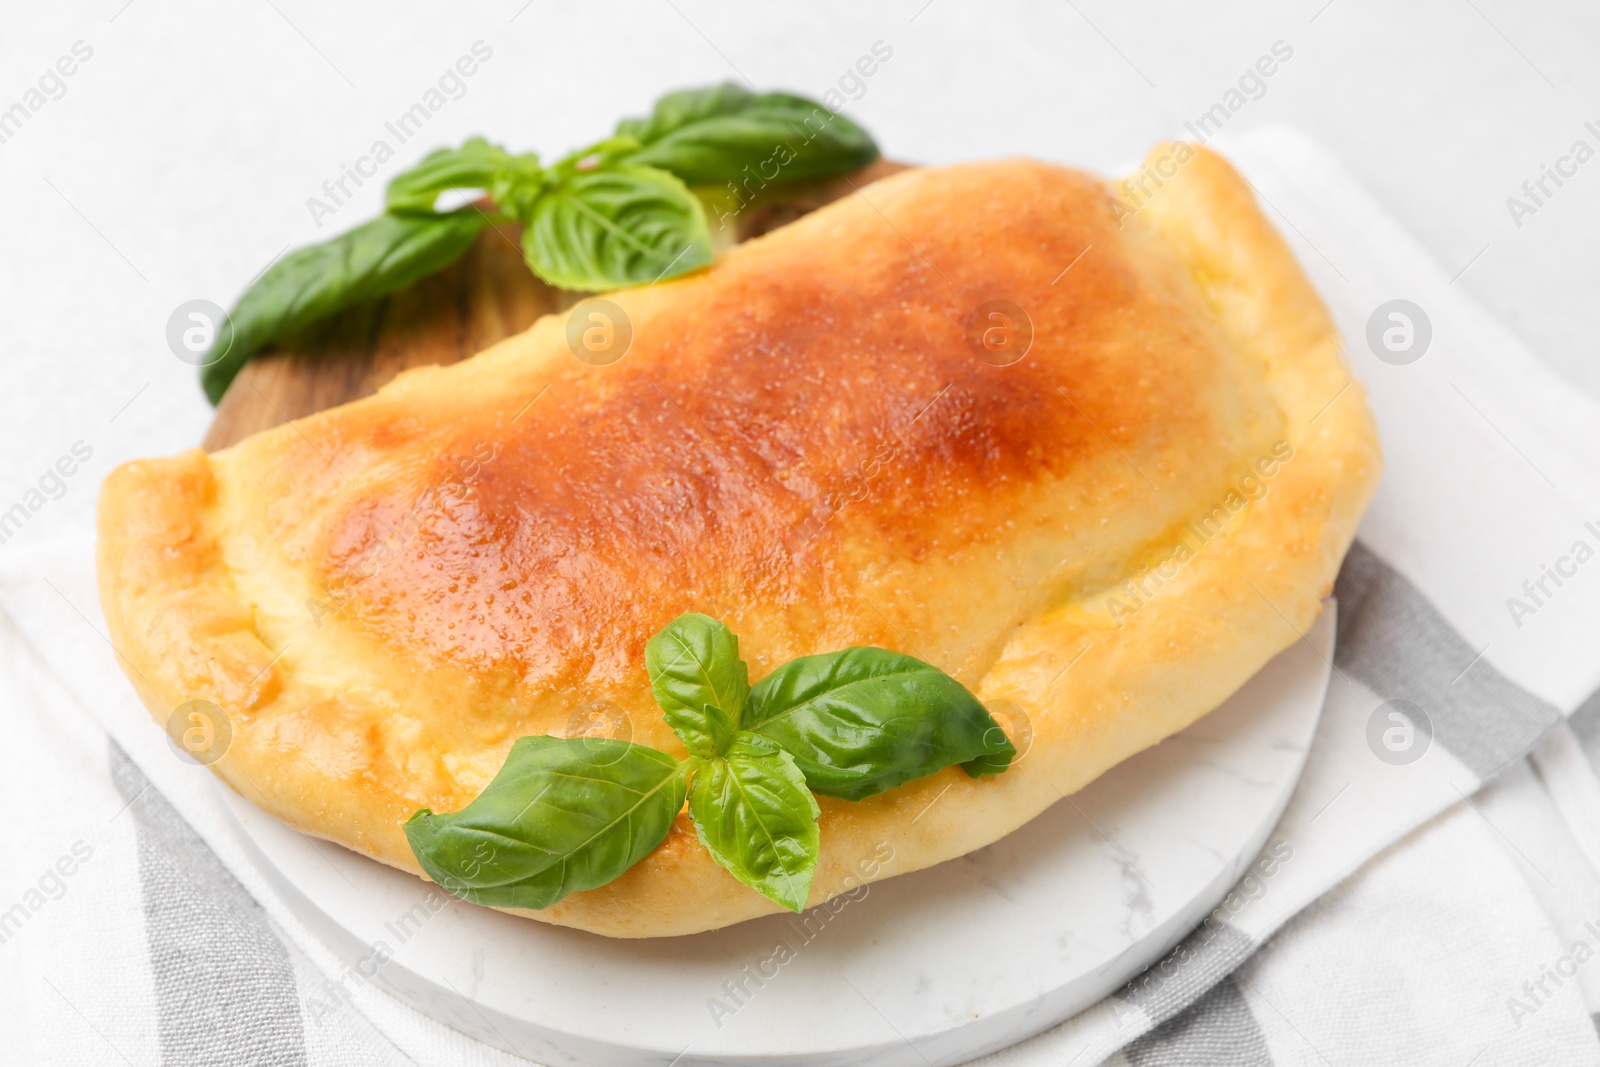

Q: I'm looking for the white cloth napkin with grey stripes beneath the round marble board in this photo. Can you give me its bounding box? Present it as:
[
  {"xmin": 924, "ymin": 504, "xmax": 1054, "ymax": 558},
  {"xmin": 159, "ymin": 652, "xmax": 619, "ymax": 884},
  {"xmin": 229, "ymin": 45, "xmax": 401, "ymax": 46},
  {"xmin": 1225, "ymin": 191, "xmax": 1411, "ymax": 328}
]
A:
[{"xmin": 0, "ymin": 128, "xmax": 1600, "ymax": 1067}]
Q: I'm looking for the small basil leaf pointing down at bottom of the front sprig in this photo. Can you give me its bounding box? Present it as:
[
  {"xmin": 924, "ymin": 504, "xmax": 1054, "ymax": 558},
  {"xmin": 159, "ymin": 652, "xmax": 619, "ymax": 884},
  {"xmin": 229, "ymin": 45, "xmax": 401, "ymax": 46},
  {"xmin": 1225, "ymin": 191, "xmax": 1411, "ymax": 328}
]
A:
[{"xmin": 690, "ymin": 733, "xmax": 821, "ymax": 912}]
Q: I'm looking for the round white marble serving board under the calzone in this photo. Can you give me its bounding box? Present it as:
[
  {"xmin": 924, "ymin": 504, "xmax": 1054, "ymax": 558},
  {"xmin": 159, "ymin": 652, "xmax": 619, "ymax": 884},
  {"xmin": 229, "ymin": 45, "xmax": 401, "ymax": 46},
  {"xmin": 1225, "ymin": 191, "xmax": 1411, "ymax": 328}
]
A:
[{"xmin": 218, "ymin": 601, "xmax": 1334, "ymax": 1067}]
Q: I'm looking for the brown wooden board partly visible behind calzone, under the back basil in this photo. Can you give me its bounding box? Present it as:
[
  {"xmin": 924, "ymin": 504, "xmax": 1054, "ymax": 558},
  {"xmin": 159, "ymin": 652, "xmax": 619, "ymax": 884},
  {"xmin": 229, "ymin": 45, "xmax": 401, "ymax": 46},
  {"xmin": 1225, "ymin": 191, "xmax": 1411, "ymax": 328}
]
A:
[{"xmin": 203, "ymin": 160, "xmax": 906, "ymax": 451}]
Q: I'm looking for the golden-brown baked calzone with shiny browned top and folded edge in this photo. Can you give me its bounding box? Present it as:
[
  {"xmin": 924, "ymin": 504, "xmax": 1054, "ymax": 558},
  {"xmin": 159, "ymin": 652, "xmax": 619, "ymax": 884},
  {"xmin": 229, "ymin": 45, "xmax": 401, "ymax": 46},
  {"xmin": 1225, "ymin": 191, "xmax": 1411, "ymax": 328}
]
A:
[{"xmin": 99, "ymin": 146, "xmax": 1379, "ymax": 937}]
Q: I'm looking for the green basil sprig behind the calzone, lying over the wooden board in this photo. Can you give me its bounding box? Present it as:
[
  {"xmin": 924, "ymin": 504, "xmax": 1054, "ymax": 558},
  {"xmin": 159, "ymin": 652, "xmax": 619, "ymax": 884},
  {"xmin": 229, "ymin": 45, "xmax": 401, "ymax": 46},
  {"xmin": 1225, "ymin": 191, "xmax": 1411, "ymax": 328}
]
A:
[{"xmin": 200, "ymin": 85, "xmax": 878, "ymax": 403}]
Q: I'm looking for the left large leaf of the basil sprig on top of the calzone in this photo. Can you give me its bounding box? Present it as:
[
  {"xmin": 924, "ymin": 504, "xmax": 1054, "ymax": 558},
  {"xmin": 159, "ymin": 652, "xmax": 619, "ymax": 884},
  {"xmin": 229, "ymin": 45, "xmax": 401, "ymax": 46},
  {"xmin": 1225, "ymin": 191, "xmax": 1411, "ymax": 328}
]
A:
[{"xmin": 405, "ymin": 737, "xmax": 685, "ymax": 909}]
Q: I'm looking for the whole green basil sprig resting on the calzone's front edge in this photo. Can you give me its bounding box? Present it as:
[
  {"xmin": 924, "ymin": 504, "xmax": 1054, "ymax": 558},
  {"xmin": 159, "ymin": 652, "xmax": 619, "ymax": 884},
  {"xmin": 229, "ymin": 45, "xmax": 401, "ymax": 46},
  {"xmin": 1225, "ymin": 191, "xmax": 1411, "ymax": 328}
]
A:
[{"xmin": 405, "ymin": 614, "xmax": 1016, "ymax": 912}]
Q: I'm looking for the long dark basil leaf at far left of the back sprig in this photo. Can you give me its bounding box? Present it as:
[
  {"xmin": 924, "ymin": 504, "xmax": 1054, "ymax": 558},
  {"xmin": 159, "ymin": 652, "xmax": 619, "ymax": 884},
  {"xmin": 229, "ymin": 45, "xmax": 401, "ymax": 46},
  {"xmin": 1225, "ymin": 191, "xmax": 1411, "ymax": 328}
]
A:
[{"xmin": 200, "ymin": 211, "xmax": 485, "ymax": 403}]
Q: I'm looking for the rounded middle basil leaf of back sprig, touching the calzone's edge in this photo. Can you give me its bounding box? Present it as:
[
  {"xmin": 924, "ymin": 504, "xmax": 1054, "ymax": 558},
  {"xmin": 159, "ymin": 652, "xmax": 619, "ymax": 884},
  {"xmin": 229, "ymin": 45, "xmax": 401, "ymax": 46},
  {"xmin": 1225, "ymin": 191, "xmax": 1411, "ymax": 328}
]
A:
[{"xmin": 522, "ymin": 163, "xmax": 712, "ymax": 290}]
